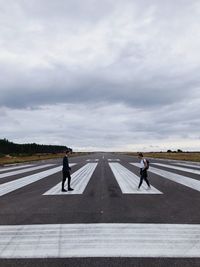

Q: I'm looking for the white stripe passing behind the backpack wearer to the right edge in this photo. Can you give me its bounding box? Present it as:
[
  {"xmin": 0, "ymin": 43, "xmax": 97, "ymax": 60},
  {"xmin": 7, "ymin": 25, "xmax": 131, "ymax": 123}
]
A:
[{"xmin": 131, "ymin": 163, "xmax": 200, "ymax": 191}]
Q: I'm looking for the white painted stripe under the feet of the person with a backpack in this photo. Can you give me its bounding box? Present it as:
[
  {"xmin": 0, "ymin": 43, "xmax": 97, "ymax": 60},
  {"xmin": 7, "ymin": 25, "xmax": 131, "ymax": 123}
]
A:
[{"xmin": 109, "ymin": 163, "xmax": 162, "ymax": 194}]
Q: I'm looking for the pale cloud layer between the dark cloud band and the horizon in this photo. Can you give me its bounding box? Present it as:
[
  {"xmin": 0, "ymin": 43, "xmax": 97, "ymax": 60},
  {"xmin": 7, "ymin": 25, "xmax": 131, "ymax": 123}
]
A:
[{"xmin": 0, "ymin": 101, "xmax": 200, "ymax": 150}]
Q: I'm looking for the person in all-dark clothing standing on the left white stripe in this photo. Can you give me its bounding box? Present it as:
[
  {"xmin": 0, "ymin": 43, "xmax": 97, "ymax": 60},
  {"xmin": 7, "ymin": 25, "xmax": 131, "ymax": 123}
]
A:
[{"xmin": 61, "ymin": 149, "xmax": 74, "ymax": 192}]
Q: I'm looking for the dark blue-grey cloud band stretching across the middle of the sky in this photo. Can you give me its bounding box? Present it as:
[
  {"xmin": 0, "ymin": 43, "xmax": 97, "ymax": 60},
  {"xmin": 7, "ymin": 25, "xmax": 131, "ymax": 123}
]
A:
[{"xmin": 0, "ymin": 61, "xmax": 198, "ymax": 108}]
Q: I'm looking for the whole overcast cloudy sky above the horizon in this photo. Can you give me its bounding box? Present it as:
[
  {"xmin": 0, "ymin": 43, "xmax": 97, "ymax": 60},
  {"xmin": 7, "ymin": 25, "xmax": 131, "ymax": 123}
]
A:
[{"xmin": 0, "ymin": 0, "xmax": 200, "ymax": 151}]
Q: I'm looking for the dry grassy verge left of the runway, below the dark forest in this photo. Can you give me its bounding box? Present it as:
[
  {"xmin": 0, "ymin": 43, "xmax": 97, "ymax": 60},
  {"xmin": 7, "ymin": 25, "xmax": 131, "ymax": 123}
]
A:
[{"xmin": 0, "ymin": 152, "xmax": 89, "ymax": 165}]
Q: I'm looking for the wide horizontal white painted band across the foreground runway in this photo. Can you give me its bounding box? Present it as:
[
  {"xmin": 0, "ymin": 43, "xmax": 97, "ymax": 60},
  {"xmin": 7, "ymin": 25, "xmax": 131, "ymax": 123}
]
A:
[{"xmin": 0, "ymin": 223, "xmax": 200, "ymax": 259}]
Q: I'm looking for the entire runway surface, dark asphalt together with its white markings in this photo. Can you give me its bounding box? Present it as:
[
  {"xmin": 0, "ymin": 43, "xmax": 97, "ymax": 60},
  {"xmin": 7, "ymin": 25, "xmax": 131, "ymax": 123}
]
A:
[{"xmin": 0, "ymin": 153, "xmax": 200, "ymax": 267}]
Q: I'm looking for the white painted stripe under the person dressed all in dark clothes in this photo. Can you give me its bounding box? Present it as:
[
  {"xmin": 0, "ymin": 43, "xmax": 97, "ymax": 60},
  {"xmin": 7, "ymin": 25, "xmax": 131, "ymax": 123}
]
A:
[{"xmin": 43, "ymin": 163, "xmax": 97, "ymax": 195}]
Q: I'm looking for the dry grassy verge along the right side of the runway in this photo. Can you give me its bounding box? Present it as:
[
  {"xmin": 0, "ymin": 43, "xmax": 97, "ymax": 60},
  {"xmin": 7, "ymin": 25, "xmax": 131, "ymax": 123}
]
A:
[{"xmin": 122, "ymin": 152, "xmax": 200, "ymax": 162}]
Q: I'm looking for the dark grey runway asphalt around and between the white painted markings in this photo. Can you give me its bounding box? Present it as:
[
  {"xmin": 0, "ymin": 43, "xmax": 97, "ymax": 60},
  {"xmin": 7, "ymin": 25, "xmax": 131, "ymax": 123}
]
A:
[{"xmin": 0, "ymin": 153, "xmax": 200, "ymax": 267}]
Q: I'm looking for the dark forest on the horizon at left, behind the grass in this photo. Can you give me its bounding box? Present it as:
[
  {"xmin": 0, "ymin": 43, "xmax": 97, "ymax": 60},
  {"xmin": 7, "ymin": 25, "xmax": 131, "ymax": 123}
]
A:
[{"xmin": 0, "ymin": 139, "xmax": 71, "ymax": 155}]
